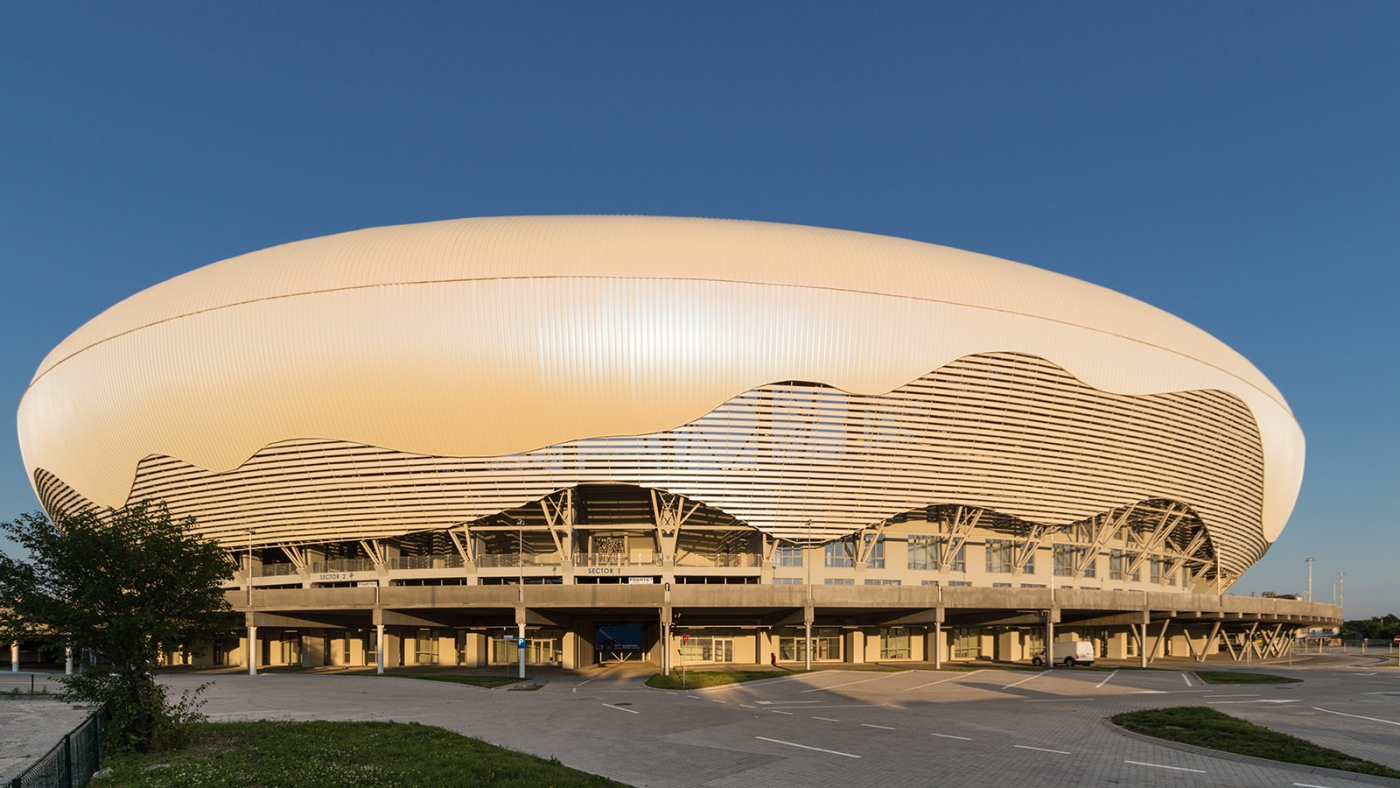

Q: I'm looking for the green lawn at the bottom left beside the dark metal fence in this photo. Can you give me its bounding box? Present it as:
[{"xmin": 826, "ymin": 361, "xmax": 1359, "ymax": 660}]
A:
[{"xmin": 91, "ymin": 722, "xmax": 622, "ymax": 788}]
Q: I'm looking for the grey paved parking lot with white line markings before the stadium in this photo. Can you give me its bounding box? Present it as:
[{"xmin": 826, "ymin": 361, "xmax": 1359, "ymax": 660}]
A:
[{"xmin": 158, "ymin": 661, "xmax": 1400, "ymax": 788}]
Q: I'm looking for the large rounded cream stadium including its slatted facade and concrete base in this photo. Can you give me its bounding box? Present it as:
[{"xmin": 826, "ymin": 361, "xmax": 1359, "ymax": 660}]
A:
[{"xmin": 18, "ymin": 217, "xmax": 1340, "ymax": 670}]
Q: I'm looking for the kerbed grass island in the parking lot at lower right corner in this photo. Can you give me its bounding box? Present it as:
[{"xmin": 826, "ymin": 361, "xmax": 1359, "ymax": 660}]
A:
[{"xmin": 1113, "ymin": 705, "xmax": 1400, "ymax": 777}]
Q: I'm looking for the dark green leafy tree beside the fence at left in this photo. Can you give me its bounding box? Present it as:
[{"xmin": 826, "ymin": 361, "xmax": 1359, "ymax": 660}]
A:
[{"xmin": 0, "ymin": 502, "xmax": 234, "ymax": 753}]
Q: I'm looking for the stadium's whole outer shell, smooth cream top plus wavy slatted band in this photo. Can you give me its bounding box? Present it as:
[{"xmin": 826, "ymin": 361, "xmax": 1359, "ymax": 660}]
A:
[{"xmin": 20, "ymin": 217, "xmax": 1302, "ymax": 593}]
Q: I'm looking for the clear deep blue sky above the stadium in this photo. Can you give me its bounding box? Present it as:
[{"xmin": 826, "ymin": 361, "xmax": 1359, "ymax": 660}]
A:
[{"xmin": 0, "ymin": 1, "xmax": 1400, "ymax": 616}]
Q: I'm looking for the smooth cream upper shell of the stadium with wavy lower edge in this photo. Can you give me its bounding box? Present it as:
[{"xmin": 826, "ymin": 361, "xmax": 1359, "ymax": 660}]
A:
[{"xmin": 18, "ymin": 217, "xmax": 1303, "ymax": 540}]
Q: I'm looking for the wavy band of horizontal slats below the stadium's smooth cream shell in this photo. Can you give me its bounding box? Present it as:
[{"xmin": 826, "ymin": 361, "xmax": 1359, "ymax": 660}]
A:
[{"xmin": 36, "ymin": 353, "xmax": 1267, "ymax": 574}]
